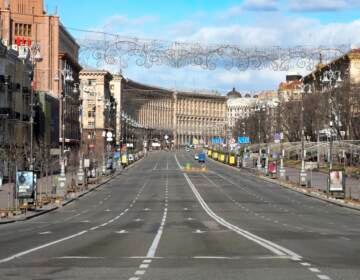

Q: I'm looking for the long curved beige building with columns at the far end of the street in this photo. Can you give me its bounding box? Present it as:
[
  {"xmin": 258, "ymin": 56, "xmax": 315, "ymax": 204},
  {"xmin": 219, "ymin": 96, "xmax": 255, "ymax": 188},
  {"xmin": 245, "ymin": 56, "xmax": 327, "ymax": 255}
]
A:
[{"xmin": 121, "ymin": 79, "xmax": 226, "ymax": 145}]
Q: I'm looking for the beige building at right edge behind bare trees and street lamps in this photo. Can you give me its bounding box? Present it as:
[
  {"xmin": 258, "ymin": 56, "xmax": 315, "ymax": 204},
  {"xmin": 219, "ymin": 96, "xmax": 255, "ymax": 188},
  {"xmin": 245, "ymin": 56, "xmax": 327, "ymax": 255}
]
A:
[{"xmin": 302, "ymin": 49, "xmax": 360, "ymax": 139}]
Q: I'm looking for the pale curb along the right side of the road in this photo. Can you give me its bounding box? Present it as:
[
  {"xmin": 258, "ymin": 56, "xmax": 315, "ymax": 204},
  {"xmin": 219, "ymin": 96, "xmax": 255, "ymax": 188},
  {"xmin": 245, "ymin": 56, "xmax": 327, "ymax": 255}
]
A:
[{"xmin": 208, "ymin": 158, "xmax": 360, "ymax": 211}]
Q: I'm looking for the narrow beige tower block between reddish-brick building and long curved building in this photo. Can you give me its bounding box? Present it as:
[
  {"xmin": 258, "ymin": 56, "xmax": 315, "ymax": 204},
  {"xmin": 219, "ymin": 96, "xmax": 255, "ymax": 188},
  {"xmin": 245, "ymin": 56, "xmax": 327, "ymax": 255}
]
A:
[{"xmin": 80, "ymin": 70, "xmax": 117, "ymax": 171}]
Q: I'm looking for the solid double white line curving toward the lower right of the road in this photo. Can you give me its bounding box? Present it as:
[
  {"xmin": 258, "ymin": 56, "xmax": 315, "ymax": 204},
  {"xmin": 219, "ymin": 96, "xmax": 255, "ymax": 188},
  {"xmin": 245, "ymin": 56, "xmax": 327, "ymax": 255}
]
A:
[{"xmin": 183, "ymin": 173, "xmax": 302, "ymax": 260}]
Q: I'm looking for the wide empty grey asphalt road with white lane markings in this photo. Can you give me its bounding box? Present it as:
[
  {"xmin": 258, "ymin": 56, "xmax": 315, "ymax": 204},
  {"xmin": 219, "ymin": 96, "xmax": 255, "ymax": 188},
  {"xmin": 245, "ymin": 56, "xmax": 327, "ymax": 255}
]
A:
[{"xmin": 0, "ymin": 152, "xmax": 360, "ymax": 280}]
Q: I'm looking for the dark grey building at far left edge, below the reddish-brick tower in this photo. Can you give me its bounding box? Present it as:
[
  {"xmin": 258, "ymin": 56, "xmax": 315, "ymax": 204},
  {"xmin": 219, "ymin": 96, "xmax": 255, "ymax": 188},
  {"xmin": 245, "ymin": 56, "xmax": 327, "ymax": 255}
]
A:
[{"xmin": 0, "ymin": 42, "xmax": 31, "ymax": 182}]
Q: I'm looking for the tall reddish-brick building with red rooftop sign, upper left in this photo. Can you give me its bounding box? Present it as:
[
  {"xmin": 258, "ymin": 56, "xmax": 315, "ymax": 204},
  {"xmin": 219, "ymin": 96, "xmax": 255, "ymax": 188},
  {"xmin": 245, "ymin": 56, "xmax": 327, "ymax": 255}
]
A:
[{"xmin": 0, "ymin": 0, "xmax": 81, "ymax": 166}]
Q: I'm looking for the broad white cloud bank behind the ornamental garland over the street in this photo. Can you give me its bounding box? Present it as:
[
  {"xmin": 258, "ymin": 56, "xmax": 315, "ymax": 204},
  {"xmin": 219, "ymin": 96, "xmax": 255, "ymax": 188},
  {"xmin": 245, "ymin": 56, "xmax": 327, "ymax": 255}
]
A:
[{"xmin": 78, "ymin": 5, "xmax": 360, "ymax": 93}]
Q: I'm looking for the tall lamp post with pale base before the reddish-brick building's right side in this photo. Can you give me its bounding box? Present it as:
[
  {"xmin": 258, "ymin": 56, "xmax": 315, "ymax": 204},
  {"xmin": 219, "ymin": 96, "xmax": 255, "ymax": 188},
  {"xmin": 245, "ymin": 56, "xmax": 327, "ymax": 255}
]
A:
[{"xmin": 59, "ymin": 65, "xmax": 74, "ymax": 196}]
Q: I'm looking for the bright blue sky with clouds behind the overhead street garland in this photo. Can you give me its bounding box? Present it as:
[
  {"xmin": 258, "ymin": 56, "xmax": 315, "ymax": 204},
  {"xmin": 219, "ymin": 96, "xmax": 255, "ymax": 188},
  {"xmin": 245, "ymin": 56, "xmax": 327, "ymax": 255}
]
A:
[{"xmin": 45, "ymin": 0, "xmax": 360, "ymax": 92}]
